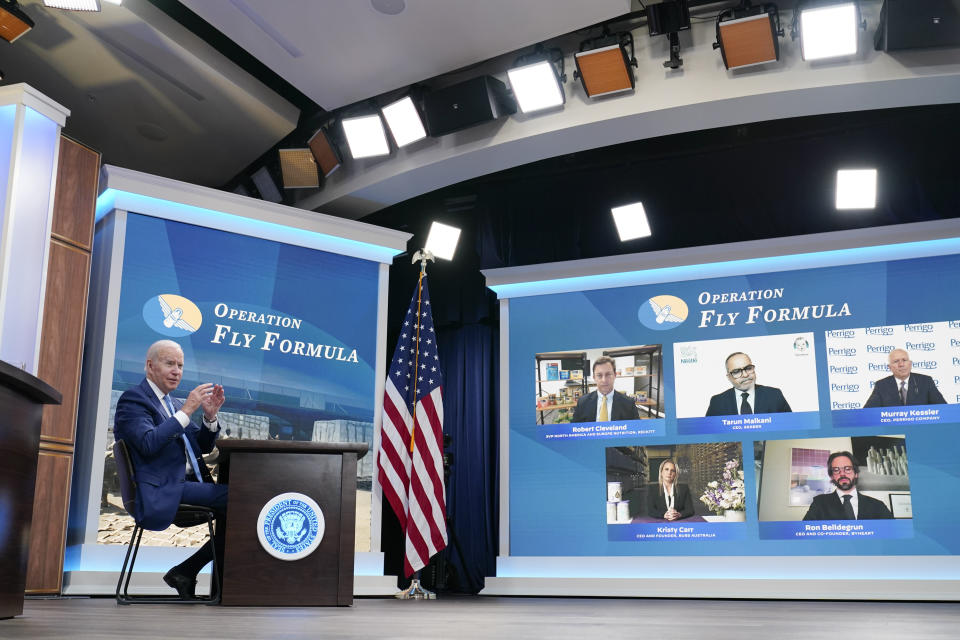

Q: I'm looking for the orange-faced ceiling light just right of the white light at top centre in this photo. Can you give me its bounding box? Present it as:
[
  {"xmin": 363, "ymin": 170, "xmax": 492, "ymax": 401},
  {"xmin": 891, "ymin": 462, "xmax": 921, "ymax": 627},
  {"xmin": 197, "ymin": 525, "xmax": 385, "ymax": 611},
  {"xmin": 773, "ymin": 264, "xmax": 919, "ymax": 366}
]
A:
[{"xmin": 573, "ymin": 27, "xmax": 637, "ymax": 98}]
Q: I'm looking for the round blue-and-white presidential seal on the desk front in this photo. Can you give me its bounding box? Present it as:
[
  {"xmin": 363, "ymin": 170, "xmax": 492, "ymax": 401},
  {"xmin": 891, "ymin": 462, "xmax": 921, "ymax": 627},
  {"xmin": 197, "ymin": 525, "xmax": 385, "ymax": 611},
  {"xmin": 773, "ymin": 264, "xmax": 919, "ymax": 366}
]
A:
[{"xmin": 257, "ymin": 492, "xmax": 325, "ymax": 560}]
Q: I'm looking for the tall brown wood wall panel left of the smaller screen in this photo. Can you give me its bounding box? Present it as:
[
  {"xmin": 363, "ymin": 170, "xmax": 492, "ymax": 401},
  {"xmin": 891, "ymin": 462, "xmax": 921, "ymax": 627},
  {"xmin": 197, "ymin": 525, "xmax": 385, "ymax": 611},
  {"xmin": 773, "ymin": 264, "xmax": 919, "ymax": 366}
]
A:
[{"xmin": 26, "ymin": 136, "xmax": 100, "ymax": 593}]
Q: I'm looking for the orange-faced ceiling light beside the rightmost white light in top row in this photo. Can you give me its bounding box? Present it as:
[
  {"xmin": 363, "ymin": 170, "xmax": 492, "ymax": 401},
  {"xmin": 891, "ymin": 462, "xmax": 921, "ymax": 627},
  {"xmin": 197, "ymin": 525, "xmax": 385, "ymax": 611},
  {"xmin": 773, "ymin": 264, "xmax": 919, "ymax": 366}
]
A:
[{"xmin": 713, "ymin": 0, "xmax": 783, "ymax": 69}]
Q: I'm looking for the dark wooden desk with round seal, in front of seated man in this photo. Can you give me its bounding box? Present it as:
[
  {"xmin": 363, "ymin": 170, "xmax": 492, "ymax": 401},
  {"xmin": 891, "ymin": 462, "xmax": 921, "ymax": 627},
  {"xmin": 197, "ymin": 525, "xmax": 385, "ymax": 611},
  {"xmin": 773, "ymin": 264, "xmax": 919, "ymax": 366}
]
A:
[{"xmin": 217, "ymin": 439, "xmax": 367, "ymax": 607}]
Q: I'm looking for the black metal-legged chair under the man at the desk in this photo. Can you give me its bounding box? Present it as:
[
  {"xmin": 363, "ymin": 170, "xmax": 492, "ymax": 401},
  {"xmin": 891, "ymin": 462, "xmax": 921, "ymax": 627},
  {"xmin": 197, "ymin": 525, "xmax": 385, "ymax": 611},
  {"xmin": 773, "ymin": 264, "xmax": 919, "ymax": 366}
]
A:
[{"xmin": 113, "ymin": 440, "xmax": 220, "ymax": 604}]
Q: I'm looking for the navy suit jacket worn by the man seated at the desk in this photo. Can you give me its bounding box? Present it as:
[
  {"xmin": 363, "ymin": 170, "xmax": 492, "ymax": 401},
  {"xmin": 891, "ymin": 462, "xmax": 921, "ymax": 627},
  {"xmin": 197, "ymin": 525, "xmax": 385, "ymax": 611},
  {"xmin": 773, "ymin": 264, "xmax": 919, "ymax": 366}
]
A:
[{"xmin": 113, "ymin": 378, "xmax": 220, "ymax": 531}]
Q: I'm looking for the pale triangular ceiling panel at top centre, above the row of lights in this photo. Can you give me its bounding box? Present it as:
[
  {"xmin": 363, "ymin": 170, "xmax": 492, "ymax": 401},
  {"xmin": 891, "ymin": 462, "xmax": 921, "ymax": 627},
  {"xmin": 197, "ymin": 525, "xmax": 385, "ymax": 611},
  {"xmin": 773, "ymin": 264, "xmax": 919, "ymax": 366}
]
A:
[{"xmin": 181, "ymin": 0, "xmax": 630, "ymax": 110}]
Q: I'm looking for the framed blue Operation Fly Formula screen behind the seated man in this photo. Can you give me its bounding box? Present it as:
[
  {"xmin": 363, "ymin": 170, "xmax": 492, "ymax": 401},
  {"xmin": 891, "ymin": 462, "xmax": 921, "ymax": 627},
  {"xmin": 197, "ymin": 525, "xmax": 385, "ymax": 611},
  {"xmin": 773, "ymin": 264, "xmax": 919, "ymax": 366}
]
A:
[{"xmin": 64, "ymin": 168, "xmax": 409, "ymax": 595}]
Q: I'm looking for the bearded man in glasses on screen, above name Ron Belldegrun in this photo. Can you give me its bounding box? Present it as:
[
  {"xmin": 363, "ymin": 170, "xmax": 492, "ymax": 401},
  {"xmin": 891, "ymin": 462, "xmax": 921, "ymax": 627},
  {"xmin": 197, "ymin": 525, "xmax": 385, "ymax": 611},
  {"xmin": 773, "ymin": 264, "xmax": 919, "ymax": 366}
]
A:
[{"xmin": 803, "ymin": 451, "xmax": 893, "ymax": 520}]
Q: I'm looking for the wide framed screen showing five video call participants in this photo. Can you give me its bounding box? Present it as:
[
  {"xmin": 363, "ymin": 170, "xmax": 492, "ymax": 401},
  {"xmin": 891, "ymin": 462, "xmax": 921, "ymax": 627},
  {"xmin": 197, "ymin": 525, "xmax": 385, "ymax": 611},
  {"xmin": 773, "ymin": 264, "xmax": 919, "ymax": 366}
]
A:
[{"xmin": 485, "ymin": 221, "xmax": 960, "ymax": 599}]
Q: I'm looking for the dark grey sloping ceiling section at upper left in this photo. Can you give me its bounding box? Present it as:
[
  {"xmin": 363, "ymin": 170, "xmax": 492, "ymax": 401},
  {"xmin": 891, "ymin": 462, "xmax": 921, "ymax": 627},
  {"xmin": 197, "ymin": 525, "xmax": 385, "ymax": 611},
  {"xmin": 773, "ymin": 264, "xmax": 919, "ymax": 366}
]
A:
[{"xmin": 0, "ymin": 0, "xmax": 299, "ymax": 186}]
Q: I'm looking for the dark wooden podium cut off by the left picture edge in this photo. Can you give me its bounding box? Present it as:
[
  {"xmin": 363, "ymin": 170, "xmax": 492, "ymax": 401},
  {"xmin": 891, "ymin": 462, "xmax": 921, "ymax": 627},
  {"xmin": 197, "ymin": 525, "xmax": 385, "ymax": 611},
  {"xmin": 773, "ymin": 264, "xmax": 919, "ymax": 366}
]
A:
[{"xmin": 0, "ymin": 361, "xmax": 61, "ymax": 618}]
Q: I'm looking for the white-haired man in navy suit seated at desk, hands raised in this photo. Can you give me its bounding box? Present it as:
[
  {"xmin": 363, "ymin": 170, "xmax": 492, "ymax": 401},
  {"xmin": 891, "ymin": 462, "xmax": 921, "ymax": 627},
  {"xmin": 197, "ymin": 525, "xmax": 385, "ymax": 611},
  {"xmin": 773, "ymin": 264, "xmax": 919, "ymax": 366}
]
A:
[{"xmin": 113, "ymin": 340, "xmax": 227, "ymax": 598}]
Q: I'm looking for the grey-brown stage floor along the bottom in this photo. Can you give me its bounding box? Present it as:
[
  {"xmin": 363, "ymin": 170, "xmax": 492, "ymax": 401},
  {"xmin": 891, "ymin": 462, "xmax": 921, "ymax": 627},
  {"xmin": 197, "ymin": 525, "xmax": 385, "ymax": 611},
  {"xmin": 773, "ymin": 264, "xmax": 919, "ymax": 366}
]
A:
[{"xmin": 7, "ymin": 582, "xmax": 960, "ymax": 640}]
